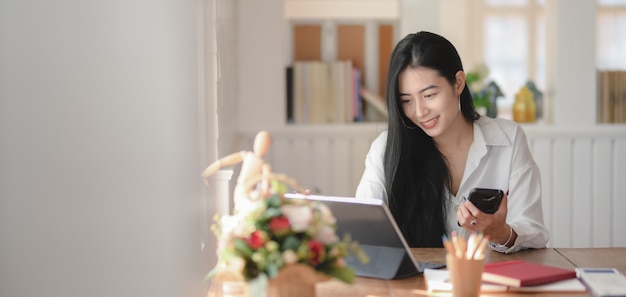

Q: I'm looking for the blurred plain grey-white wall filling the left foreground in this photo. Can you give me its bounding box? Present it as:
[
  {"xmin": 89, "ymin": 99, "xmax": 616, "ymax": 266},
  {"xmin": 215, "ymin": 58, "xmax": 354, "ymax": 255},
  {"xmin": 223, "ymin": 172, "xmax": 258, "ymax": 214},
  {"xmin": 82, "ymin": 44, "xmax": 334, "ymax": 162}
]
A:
[{"xmin": 0, "ymin": 0, "xmax": 209, "ymax": 297}]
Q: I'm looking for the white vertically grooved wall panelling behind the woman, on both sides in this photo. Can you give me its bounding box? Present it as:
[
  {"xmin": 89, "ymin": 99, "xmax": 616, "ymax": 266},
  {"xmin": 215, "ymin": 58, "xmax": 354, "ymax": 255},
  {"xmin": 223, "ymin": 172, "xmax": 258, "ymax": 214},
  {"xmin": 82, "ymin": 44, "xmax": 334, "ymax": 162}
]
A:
[{"xmin": 242, "ymin": 124, "xmax": 626, "ymax": 247}]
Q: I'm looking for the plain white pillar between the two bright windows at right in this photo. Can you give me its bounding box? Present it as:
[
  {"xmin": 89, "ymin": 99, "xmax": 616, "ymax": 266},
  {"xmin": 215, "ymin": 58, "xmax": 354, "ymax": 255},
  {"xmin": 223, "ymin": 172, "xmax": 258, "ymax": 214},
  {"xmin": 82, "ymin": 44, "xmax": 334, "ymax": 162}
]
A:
[{"xmin": 546, "ymin": 0, "xmax": 597, "ymax": 126}]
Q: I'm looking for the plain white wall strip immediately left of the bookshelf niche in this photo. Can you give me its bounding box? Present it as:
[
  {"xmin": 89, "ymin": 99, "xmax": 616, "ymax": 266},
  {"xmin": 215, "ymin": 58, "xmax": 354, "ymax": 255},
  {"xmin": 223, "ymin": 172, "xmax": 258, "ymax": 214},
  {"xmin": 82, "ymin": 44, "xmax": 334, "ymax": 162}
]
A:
[{"xmin": 236, "ymin": 0, "xmax": 286, "ymax": 131}]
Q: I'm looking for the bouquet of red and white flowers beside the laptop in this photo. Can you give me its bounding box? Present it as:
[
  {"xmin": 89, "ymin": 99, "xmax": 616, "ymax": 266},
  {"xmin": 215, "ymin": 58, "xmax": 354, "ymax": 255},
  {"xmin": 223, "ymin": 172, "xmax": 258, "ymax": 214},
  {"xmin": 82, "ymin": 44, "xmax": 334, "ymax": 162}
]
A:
[{"xmin": 214, "ymin": 181, "xmax": 364, "ymax": 283}]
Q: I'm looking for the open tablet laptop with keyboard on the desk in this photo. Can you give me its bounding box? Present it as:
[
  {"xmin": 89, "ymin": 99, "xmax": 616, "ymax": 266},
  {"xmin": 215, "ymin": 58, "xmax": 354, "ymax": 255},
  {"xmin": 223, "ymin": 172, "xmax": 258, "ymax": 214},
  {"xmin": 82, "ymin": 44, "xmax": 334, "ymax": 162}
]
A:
[{"xmin": 285, "ymin": 194, "xmax": 424, "ymax": 279}]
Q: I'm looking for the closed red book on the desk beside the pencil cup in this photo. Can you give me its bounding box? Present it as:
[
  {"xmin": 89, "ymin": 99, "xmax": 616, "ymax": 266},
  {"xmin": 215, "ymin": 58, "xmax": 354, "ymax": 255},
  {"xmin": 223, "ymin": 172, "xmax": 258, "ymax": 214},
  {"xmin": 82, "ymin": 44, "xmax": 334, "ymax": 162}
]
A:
[{"xmin": 483, "ymin": 260, "xmax": 576, "ymax": 287}]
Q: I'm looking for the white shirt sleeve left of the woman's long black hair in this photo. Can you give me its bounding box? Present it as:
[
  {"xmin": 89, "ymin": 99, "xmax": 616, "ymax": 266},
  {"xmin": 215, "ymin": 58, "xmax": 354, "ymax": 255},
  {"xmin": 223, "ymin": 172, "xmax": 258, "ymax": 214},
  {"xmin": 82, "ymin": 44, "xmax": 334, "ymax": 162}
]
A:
[{"xmin": 355, "ymin": 131, "xmax": 387, "ymax": 203}]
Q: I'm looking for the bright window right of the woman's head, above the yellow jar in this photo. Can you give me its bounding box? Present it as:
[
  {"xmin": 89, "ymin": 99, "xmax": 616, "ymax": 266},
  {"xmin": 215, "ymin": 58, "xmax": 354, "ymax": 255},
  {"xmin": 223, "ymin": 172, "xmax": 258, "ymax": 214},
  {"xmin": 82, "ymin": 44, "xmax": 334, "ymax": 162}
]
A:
[{"xmin": 468, "ymin": 0, "xmax": 546, "ymax": 118}]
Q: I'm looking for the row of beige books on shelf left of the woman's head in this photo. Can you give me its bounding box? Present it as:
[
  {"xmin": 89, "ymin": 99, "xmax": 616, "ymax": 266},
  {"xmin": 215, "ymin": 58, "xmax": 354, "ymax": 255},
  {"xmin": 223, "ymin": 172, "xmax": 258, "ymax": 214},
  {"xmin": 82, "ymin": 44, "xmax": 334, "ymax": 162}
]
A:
[{"xmin": 286, "ymin": 60, "xmax": 362, "ymax": 124}]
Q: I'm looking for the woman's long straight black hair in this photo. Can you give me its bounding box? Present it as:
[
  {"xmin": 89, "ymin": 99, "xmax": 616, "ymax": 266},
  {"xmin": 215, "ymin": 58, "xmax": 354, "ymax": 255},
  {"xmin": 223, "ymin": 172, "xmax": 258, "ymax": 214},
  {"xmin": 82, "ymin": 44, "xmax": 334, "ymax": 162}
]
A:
[{"xmin": 384, "ymin": 32, "xmax": 479, "ymax": 247}]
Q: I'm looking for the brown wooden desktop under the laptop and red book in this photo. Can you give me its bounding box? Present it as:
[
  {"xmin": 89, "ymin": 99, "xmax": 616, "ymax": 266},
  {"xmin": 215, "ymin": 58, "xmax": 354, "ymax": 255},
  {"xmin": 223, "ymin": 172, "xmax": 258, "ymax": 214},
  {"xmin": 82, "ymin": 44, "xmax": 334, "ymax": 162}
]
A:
[{"xmin": 317, "ymin": 248, "xmax": 626, "ymax": 297}]
